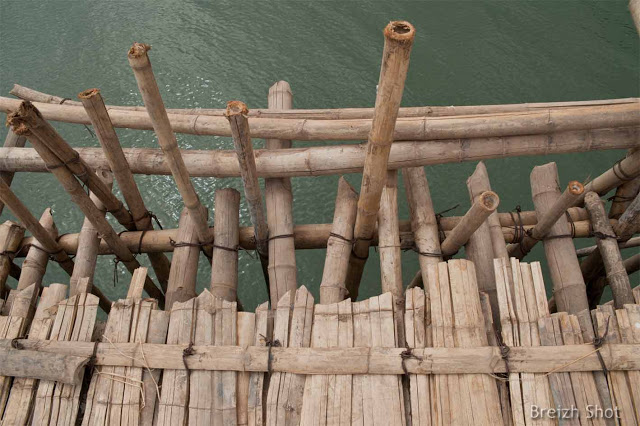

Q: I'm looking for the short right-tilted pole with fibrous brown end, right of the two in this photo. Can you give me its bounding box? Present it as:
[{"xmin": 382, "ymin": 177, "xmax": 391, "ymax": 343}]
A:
[{"xmin": 508, "ymin": 180, "xmax": 584, "ymax": 259}]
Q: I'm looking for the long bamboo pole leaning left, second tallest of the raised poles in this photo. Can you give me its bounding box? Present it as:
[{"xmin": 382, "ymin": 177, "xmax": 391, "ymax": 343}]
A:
[{"xmin": 126, "ymin": 43, "xmax": 211, "ymax": 250}]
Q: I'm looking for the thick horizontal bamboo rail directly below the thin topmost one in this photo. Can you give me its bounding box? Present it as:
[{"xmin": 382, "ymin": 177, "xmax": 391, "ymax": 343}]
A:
[{"xmin": 0, "ymin": 97, "xmax": 640, "ymax": 140}]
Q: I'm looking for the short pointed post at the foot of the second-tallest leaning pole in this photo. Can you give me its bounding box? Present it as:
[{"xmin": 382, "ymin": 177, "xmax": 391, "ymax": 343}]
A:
[{"xmin": 164, "ymin": 207, "xmax": 200, "ymax": 311}]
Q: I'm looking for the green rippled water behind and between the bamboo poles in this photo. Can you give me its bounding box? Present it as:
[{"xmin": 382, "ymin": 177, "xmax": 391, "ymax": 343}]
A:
[{"xmin": 0, "ymin": 0, "xmax": 640, "ymax": 309}]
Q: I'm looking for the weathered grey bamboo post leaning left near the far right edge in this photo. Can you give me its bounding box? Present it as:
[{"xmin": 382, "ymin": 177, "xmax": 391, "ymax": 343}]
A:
[{"xmin": 584, "ymin": 192, "xmax": 634, "ymax": 309}]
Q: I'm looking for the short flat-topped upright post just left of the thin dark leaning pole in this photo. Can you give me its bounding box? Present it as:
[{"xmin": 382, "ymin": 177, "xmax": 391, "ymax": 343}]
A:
[{"xmin": 211, "ymin": 188, "xmax": 240, "ymax": 302}]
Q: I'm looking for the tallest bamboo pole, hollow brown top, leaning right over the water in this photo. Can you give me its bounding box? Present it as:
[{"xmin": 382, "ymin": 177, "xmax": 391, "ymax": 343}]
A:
[{"xmin": 347, "ymin": 21, "xmax": 415, "ymax": 300}]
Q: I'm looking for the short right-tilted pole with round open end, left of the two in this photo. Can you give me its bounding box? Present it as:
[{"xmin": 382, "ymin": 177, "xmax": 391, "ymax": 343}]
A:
[{"xmin": 440, "ymin": 191, "xmax": 500, "ymax": 256}]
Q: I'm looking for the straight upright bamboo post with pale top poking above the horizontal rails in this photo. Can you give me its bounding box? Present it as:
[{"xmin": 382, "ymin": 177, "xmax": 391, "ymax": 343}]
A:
[{"xmin": 264, "ymin": 81, "xmax": 296, "ymax": 303}]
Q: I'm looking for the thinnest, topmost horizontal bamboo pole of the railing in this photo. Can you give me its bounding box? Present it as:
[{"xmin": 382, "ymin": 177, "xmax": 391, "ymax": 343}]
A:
[{"xmin": 9, "ymin": 83, "xmax": 638, "ymax": 120}]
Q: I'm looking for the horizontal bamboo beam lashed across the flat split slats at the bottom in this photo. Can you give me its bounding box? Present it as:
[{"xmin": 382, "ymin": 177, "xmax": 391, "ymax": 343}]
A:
[{"xmin": 0, "ymin": 339, "xmax": 640, "ymax": 375}]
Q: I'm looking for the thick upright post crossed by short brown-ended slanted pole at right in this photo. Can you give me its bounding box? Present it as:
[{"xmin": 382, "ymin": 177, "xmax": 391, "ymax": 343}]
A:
[{"xmin": 531, "ymin": 163, "xmax": 589, "ymax": 314}]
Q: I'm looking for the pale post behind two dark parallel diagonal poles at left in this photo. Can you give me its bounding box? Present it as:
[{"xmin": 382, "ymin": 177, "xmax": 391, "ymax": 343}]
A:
[{"xmin": 69, "ymin": 170, "xmax": 113, "ymax": 297}]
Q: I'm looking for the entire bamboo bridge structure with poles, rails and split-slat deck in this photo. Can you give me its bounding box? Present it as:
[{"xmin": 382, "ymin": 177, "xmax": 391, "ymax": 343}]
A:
[{"xmin": 0, "ymin": 15, "xmax": 640, "ymax": 425}]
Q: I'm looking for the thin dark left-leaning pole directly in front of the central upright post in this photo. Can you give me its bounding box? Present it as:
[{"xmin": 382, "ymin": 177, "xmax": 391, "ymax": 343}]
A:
[{"xmin": 226, "ymin": 101, "xmax": 270, "ymax": 292}]
